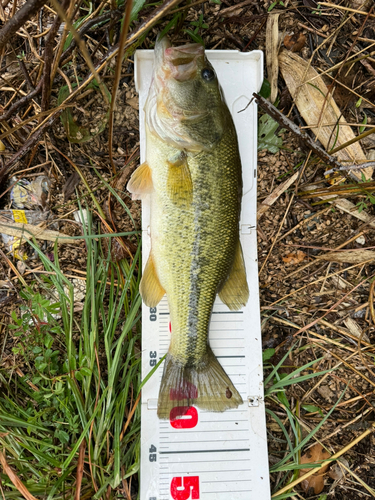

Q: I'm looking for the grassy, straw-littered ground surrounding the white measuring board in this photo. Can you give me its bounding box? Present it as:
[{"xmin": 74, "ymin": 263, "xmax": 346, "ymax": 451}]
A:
[{"xmin": 0, "ymin": 0, "xmax": 375, "ymax": 500}]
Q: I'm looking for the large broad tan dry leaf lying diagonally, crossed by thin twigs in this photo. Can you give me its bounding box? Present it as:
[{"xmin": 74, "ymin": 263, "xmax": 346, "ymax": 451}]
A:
[{"xmin": 279, "ymin": 50, "xmax": 373, "ymax": 179}]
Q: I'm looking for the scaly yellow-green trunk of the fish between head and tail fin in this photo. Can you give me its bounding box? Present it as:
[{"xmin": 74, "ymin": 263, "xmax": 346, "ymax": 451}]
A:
[{"xmin": 147, "ymin": 121, "xmax": 241, "ymax": 363}]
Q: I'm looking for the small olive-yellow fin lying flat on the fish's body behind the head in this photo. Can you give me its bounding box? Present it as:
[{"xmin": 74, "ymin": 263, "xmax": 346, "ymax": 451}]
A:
[{"xmin": 167, "ymin": 151, "xmax": 193, "ymax": 206}]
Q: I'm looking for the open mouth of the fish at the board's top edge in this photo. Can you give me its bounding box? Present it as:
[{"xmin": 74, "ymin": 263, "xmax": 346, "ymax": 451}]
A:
[{"xmin": 155, "ymin": 37, "xmax": 204, "ymax": 82}]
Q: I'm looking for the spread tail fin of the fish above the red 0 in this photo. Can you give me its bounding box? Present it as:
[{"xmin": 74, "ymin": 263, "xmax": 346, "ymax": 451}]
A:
[{"xmin": 158, "ymin": 347, "xmax": 243, "ymax": 419}]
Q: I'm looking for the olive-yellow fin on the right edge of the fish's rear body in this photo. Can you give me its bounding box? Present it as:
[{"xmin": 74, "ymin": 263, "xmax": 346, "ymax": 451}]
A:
[{"xmin": 219, "ymin": 240, "xmax": 249, "ymax": 310}]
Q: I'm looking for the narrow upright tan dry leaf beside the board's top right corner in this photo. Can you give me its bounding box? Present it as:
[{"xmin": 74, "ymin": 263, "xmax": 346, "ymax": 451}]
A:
[{"xmin": 266, "ymin": 14, "xmax": 279, "ymax": 103}]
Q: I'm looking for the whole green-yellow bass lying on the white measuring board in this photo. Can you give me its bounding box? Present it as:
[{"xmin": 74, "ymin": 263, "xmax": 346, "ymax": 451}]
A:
[{"xmin": 127, "ymin": 37, "xmax": 249, "ymax": 419}]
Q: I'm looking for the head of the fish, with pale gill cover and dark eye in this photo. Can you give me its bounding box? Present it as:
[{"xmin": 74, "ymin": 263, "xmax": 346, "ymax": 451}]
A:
[{"xmin": 145, "ymin": 37, "xmax": 227, "ymax": 151}]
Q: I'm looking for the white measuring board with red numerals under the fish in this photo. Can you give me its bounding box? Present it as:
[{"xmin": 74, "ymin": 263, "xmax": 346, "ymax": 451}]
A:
[{"xmin": 135, "ymin": 50, "xmax": 270, "ymax": 500}]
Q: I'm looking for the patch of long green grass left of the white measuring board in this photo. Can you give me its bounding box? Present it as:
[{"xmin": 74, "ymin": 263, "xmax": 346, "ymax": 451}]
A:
[{"xmin": 0, "ymin": 206, "xmax": 141, "ymax": 500}]
